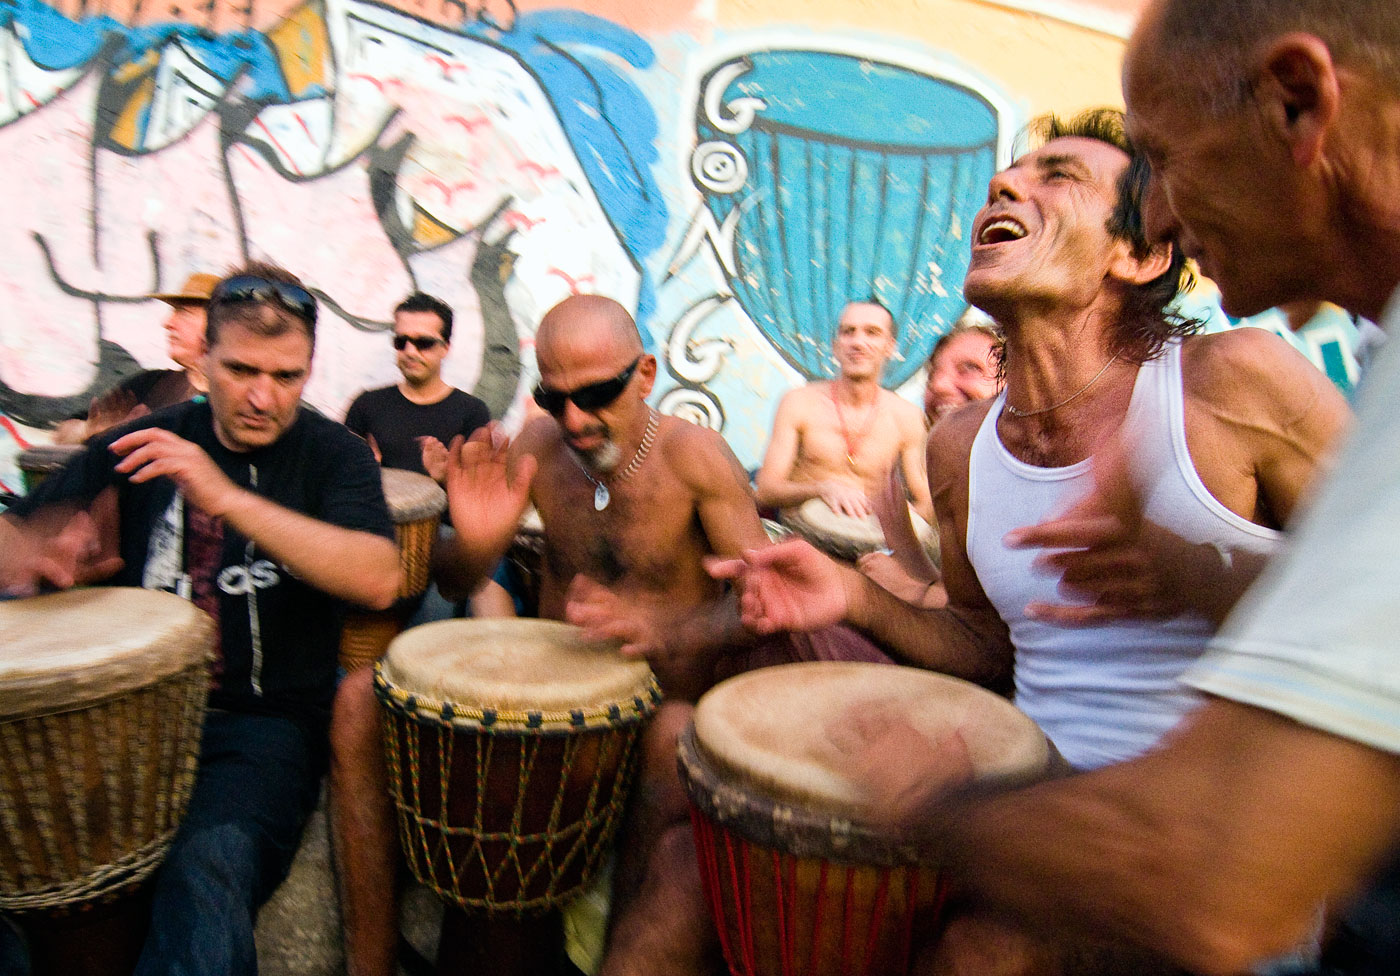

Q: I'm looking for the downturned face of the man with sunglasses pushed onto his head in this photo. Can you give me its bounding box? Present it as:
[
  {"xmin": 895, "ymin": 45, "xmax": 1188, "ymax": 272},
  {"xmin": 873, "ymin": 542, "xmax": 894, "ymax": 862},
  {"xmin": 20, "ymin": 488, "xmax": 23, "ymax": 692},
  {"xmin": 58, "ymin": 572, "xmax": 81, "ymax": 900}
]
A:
[{"xmin": 204, "ymin": 323, "xmax": 311, "ymax": 451}]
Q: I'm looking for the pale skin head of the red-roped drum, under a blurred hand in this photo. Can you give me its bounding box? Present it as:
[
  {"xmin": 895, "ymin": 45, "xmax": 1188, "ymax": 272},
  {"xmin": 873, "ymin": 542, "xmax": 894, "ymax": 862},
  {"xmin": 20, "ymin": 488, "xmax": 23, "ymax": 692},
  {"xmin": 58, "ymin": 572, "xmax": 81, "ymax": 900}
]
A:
[{"xmin": 694, "ymin": 661, "xmax": 1049, "ymax": 821}]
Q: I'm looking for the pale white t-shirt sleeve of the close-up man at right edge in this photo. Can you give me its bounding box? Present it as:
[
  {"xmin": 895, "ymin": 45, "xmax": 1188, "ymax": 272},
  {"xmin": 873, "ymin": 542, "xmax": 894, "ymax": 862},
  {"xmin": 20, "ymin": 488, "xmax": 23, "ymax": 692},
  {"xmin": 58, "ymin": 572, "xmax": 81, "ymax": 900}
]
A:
[{"xmin": 1183, "ymin": 293, "xmax": 1400, "ymax": 752}]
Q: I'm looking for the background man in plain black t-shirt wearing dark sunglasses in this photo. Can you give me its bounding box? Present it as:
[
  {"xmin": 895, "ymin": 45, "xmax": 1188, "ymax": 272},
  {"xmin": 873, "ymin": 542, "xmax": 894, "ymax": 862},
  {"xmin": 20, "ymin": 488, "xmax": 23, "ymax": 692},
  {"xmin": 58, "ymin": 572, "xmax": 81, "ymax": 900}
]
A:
[{"xmin": 346, "ymin": 291, "xmax": 491, "ymax": 482}]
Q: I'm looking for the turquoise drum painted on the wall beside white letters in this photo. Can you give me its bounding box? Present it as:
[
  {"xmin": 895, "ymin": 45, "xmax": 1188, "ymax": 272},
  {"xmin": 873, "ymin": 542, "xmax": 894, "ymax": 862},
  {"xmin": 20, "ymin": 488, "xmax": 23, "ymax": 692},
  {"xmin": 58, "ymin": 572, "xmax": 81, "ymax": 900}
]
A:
[{"xmin": 692, "ymin": 50, "xmax": 1000, "ymax": 386}]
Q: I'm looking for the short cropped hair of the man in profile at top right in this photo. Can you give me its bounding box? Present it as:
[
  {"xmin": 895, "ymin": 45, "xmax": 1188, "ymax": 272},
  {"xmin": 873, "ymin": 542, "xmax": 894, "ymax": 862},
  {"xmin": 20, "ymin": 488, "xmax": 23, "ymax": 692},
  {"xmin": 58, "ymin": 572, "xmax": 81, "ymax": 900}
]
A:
[{"xmin": 1155, "ymin": 0, "xmax": 1400, "ymax": 118}]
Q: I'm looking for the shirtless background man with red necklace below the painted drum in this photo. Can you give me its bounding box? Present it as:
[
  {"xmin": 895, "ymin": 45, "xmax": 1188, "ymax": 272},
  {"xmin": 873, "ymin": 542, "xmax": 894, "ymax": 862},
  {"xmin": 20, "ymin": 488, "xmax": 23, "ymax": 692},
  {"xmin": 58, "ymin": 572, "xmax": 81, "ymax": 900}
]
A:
[{"xmin": 755, "ymin": 300, "xmax": 934, "ymax": 521}]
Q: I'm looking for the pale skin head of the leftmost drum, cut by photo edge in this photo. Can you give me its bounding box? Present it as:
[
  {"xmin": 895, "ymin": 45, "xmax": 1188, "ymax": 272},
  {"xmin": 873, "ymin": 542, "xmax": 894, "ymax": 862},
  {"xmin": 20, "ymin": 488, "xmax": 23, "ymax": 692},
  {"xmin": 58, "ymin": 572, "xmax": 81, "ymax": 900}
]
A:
[{"xmin": 0, "ymin": 587, "xmax": 214, "ymax": 720}]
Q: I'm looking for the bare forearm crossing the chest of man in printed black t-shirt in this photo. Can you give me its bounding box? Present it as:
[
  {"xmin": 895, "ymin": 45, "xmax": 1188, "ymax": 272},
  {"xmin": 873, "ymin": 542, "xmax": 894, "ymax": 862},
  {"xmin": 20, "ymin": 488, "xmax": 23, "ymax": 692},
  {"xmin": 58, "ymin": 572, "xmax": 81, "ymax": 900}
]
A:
[{"xmin": 221, "ymin": 489, "xmax": 399, "ymax": 609}]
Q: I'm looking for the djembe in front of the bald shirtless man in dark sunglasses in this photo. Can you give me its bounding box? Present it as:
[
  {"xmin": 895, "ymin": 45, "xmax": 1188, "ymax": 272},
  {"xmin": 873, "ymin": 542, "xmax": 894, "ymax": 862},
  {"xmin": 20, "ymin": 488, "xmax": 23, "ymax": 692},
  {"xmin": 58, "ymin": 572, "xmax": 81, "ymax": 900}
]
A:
[{"xmin": 374, "ymin": 619, "xmax": 661, "ymax": 973}]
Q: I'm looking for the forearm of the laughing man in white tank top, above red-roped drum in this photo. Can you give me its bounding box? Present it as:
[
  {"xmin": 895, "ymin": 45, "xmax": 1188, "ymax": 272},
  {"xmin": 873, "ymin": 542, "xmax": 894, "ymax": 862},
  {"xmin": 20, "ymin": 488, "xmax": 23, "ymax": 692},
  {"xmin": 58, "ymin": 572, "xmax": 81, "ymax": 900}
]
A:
[{"xmin": 841, "ymin": 567, "xmax": 1014, "ymax": 685}]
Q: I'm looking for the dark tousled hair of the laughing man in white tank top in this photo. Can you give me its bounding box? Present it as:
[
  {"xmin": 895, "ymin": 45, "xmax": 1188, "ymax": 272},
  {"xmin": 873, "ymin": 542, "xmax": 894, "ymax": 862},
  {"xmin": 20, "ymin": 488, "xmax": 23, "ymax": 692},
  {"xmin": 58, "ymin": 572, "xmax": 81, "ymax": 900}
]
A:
[{"xmin": 1028, "ymin": 108, "xmax": 1204, "ymax": 364}]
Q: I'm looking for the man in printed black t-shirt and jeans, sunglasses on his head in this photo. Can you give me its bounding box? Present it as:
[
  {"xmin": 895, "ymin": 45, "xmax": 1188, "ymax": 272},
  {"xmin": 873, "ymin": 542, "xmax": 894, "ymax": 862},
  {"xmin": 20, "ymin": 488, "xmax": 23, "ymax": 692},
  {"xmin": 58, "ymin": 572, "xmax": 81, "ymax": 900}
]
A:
[{"xmin": 0, "ymin": 265, "xmax": 399, "ymax": 976}]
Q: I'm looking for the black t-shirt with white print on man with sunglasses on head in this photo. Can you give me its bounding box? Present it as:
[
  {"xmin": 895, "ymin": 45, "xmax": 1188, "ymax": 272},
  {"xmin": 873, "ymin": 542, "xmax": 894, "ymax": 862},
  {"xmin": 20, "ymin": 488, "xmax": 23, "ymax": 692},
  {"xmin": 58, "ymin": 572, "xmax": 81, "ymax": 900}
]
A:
[{"xmin": 11, "ymin": 402, "xmax": 393, "ymax": 725}]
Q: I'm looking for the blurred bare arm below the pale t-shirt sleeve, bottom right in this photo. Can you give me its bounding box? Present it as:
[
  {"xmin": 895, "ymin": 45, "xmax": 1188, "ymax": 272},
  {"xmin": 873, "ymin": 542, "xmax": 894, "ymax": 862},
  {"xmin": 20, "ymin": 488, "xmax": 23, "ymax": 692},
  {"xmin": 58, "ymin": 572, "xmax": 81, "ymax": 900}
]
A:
[{"xmin": 916, "ymin": 702, "xmax": 1400, "ymax": 973}]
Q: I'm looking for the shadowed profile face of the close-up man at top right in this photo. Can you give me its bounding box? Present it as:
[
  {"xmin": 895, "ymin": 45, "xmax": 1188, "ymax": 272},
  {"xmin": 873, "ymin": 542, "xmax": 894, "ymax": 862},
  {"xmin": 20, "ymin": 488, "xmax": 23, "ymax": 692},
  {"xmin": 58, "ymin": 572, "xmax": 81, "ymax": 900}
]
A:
[{"xmin": 1123, "ymin": 33, "xmax": 1317, "ymax": 315}]
